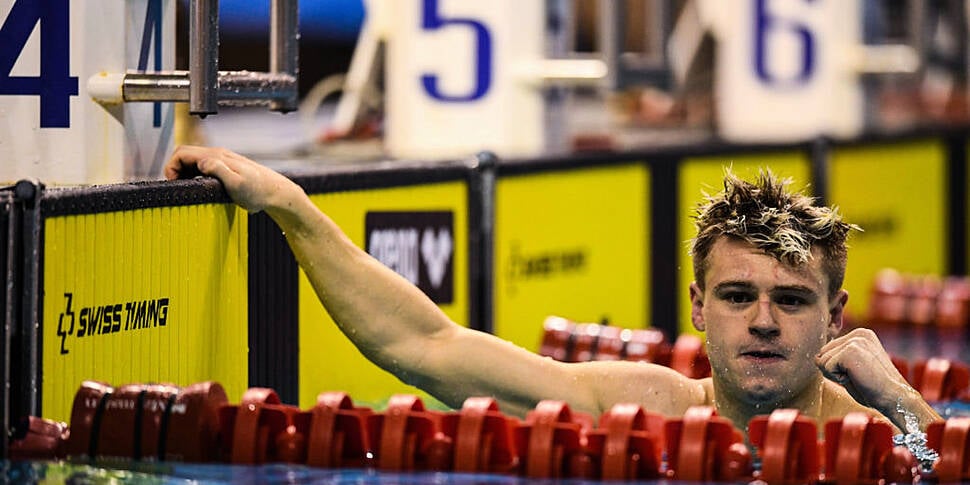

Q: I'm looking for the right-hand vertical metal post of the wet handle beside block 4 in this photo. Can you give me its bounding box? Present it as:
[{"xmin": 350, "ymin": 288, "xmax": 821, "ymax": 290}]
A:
[{"xmin": 269, "ymin": 0, "xmax": 300, "ymax": 113}]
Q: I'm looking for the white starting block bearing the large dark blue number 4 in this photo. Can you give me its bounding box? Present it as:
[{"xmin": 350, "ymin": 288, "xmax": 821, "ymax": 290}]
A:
[{"xmin": 0, "ymin": 0, "xmax": 175, "ymax": 184}]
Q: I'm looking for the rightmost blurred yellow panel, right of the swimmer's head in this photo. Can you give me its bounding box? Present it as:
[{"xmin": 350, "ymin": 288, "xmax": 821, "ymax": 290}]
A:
[{"xmin": 829, "ymin": 140, "xmax": 947, "ymax": 323}]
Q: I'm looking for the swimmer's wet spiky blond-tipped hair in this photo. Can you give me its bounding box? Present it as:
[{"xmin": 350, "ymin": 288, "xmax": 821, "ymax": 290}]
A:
[{"xmin": 690, "ymin": 169, "xmax": 860, "ymax": 296}]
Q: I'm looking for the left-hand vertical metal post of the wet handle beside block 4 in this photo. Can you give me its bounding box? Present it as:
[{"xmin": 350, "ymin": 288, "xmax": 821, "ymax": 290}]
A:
[{"xmin": 189, "ymin": 0, "xmax": 219, "ymax": 118}]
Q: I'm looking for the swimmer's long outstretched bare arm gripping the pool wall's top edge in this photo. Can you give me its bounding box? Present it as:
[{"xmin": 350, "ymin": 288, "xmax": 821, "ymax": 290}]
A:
[{"xmin": 165, "ymin": 146, "xmax": 704, "ymax": 415}]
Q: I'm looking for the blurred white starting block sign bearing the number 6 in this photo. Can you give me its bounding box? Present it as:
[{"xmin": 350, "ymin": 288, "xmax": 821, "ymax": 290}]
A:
[{"xmin": 700, "ymin": 0, "xmax": 864, "ymax": 141}]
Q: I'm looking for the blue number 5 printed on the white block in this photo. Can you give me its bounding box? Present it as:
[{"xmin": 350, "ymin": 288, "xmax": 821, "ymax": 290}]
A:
[{"xmin": 421, "ymin": 0, "xmax": 492, "ymax": 103}]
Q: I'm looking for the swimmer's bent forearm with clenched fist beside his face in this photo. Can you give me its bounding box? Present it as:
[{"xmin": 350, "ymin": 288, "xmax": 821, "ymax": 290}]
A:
[{"xmin": 816, "ymin": 328, "xmax": 942, "ymax": 432}]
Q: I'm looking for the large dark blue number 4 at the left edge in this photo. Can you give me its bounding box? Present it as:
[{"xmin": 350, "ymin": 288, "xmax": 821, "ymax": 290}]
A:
[{"xmin": 0, "ymin": 0, "xmax": 78, "ymax": 128}]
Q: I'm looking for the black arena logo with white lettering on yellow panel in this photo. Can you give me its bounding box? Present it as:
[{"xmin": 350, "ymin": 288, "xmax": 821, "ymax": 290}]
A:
[{"xmin": 364, "ymin": 211, "xmax": 455, "ymax": 303}]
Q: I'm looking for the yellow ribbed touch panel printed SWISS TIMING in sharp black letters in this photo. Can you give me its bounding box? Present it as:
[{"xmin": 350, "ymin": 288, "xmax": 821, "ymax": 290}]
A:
[{"xmin": 41, "ymin": 204, "xmax": 248, "ymax": 421}]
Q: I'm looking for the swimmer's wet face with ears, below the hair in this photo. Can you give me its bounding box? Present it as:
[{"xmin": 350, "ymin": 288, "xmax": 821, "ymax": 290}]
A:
[{"xmin": 691, "ymin": 238, "xmax": 845, "ymax": 406}]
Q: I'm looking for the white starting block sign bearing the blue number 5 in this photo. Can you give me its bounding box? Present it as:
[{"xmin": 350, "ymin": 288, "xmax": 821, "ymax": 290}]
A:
[{"xmin": 384, "ymin": 0, "xmax": 545, "ymax": 158}]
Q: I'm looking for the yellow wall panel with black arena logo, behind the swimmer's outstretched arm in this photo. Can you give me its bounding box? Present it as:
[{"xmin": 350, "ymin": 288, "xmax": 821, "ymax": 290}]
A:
[{"xmin": 299, "ymin": 181, "xmax": 469, "ymax": 408}]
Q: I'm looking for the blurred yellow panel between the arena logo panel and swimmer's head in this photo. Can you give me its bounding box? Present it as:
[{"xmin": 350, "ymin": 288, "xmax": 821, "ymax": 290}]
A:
[{"xmin": 494, "ymin": 164, "xmax": 651, "ymax": 352}]
